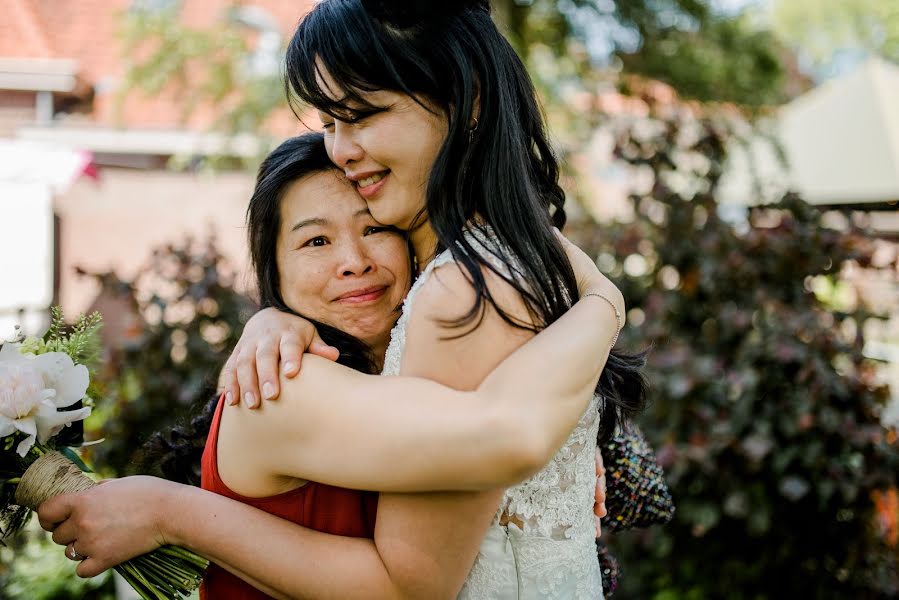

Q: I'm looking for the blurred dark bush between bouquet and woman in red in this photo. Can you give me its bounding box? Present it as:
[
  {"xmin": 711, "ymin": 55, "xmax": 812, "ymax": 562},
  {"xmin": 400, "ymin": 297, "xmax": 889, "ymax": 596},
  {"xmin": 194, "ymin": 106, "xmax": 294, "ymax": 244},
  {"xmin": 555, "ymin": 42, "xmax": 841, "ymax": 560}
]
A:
[{"xmin": 86, "ymin": 238, "xmax": 256, "ymax": 476}]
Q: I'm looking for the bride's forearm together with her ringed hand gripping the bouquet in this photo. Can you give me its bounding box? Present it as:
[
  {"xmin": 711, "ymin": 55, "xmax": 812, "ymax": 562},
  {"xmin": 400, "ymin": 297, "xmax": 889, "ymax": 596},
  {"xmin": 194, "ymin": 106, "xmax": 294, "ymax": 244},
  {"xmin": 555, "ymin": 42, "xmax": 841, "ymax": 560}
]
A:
[{"xmin": 38, "ymin": 476, "xmax": 450, "ymax": 600}]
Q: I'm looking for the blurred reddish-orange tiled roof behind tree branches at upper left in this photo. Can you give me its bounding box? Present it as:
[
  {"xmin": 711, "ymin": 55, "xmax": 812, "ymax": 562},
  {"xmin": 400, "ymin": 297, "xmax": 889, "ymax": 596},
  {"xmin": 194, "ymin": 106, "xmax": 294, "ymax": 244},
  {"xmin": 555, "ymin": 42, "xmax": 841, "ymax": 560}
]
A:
[{"xmin": 0, "ymin": 0, "xmax": 314, "ymax": 134}]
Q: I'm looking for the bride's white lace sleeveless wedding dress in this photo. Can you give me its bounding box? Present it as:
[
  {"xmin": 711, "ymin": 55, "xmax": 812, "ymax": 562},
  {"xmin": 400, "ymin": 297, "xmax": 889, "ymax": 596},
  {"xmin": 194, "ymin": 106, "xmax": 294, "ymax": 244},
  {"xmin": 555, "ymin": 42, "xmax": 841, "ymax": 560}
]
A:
[{"xmin": 383, "ymin": 230, "xmax": 603, "ymax": 600}]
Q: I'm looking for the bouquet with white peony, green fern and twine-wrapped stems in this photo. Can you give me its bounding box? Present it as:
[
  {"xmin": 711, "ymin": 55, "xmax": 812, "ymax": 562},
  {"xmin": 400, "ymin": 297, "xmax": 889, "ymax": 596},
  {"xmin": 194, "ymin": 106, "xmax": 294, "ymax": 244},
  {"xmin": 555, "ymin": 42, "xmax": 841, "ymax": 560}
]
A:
[{"xmin": 0, "ymin": 308, "xmax": 208, "ymax": 600}]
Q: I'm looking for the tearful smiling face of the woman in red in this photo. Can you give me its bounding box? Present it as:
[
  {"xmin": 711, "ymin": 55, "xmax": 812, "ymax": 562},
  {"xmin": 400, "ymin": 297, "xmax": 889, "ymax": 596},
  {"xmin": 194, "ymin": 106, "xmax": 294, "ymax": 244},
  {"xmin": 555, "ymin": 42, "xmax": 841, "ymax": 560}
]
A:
[{"xmin": 276, "ymin": 170, "xmax": 411, "ymax": 356}]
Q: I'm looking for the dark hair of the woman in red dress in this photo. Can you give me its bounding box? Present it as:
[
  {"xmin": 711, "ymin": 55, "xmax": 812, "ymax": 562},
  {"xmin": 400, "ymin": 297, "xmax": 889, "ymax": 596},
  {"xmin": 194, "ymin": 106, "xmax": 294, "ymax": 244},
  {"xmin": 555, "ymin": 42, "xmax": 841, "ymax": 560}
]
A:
[{"xmin": 140, "ymin": 133, "xmax": 378, "ymax": 485}]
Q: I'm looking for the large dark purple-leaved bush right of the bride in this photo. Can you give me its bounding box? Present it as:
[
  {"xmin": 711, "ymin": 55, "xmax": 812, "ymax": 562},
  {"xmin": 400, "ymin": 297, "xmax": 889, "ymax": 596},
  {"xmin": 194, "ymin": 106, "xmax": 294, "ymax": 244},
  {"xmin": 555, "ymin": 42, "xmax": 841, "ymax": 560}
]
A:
[{"xmin": 574, "ymin": 86, "xmax": 899, "ymax": 600}]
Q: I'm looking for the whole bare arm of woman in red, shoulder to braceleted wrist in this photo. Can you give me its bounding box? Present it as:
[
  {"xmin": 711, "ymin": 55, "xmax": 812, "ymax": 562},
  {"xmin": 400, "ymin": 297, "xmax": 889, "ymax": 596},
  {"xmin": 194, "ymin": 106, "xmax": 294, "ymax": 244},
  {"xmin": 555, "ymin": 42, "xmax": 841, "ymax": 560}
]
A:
[{"xmin": 216, "ymin": 264, "xmax": 616, "ymax": 492}]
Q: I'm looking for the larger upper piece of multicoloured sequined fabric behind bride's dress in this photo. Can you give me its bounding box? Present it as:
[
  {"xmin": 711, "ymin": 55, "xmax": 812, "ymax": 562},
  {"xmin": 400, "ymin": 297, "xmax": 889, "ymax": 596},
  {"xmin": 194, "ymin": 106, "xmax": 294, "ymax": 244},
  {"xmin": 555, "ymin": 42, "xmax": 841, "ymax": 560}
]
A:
[{"xmin": 601, "ymin": 425, "xmax": 674, "ymax": 531}]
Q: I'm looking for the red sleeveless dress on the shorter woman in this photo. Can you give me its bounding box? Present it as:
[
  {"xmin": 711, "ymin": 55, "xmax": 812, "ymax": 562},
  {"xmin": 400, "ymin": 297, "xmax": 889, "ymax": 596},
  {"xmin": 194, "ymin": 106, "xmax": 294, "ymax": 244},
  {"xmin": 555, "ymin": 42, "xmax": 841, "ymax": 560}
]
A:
[{"xmin": 200, "ymin": 398, "xmax": 378, "ymax": 600}]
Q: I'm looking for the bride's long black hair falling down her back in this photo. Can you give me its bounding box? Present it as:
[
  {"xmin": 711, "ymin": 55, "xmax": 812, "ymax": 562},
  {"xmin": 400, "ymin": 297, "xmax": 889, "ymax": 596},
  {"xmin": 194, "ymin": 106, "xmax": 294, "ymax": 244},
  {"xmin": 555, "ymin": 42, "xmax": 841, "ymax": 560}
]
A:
[{"xmin": 286, "ymin": 0, "xmax": 646, "ymax": 439}]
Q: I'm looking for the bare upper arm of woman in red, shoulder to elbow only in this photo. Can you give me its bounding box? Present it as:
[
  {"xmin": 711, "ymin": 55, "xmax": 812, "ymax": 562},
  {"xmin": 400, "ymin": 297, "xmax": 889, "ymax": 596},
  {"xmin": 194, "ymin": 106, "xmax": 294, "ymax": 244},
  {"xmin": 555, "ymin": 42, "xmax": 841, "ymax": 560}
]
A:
[{"xmin": 239, "ymin": 364, "xmax": 524, "ymax": 492}]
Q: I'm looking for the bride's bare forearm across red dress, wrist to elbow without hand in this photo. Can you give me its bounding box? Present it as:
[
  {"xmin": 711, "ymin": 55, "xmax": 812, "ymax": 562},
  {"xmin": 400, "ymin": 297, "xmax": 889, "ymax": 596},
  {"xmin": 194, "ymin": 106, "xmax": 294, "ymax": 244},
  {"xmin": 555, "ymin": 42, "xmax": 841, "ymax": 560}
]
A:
[{"xmin": 162, "ymin": 486, "xmax": 404, "ymax": 600}]
